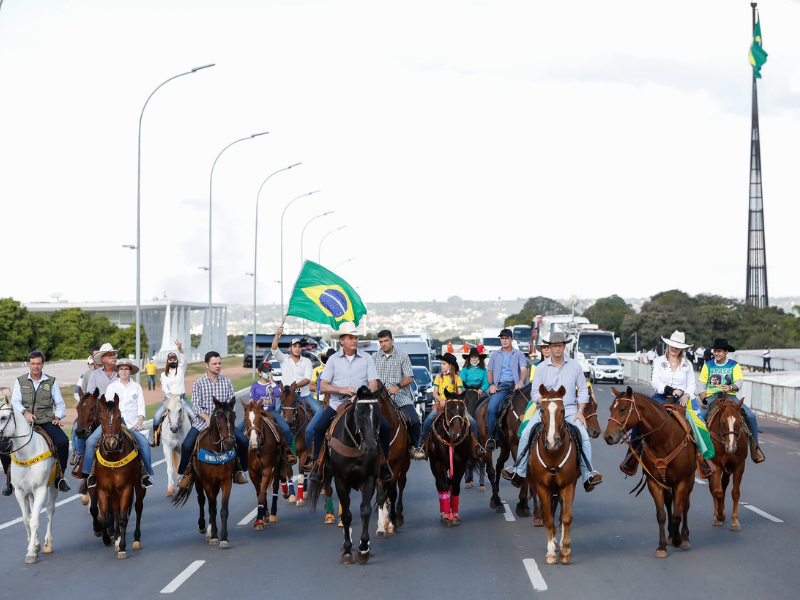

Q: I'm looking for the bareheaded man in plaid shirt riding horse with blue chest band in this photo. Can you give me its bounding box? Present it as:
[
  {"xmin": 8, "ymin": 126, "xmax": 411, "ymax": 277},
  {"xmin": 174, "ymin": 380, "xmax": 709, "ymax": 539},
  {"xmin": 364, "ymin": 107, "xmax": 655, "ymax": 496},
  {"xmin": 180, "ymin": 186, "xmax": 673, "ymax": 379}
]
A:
[{"xmin": 178, "ymin": 350, "xmax": 247, "ymax": 489}]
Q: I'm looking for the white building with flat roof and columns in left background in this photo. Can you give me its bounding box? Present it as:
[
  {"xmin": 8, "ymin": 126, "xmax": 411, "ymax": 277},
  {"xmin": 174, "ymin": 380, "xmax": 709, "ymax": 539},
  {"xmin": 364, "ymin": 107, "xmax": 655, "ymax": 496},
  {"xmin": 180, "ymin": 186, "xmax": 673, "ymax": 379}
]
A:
[{"xmin": 24, "ymin": 300, "xmax": 228, "ymax": 364}]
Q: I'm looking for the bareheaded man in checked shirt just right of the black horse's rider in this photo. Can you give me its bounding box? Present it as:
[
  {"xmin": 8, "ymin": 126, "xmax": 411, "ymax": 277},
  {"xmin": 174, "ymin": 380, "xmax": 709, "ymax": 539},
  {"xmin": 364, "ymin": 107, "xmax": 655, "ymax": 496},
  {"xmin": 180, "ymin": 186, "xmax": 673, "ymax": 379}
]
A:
[{"xmin": 373, "ymin": 329, "xmax": 425, "ymax": 460}]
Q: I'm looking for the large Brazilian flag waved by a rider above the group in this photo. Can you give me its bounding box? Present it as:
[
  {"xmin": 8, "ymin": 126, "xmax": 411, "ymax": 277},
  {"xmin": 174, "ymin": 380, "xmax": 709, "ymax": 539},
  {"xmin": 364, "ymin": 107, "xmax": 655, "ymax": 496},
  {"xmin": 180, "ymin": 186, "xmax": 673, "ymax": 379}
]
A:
[{"xmin": 286, "ymin": 260, "xmax": 367, "ymax": 329}]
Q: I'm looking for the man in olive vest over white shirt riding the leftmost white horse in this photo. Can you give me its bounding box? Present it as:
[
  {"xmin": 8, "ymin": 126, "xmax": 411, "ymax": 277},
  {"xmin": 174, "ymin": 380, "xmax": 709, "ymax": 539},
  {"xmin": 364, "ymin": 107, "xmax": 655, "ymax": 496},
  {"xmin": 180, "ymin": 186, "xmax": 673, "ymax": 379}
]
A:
[{"xmin": 0, "ymin": 350, "xmax": 70, "ymax": 496}]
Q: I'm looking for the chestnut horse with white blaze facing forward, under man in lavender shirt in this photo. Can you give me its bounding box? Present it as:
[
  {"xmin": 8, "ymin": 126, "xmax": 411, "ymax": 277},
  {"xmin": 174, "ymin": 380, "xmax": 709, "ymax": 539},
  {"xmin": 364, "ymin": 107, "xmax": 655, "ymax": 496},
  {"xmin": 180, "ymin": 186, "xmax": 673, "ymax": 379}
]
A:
[{"xmin": 526, "ymin": 385, "xmax": 581, "ymax": 565}]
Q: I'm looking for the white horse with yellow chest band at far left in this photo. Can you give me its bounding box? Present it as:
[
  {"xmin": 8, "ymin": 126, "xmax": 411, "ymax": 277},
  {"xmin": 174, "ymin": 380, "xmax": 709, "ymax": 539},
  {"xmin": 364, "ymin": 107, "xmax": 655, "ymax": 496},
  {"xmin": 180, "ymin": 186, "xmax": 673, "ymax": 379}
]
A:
[{"xmin": 0, "ymin": 398, "xmax": 58, "ymax": 565}]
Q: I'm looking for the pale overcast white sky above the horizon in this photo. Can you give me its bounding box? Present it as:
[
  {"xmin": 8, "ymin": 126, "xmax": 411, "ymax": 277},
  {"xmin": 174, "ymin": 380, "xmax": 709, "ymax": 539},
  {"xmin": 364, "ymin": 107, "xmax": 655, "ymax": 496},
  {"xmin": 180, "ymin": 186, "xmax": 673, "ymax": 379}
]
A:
[{"xmin": 0, "ymin": 0, "xmax": 800, "ymax": 304}]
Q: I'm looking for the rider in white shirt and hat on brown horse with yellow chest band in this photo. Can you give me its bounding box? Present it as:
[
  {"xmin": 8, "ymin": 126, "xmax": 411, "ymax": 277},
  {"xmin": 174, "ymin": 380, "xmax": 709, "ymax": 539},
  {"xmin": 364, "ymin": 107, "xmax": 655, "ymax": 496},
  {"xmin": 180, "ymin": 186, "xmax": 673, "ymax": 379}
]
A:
[{"xmin": 83, "ymin": 358, "xmax": 153, "ymax": 488}]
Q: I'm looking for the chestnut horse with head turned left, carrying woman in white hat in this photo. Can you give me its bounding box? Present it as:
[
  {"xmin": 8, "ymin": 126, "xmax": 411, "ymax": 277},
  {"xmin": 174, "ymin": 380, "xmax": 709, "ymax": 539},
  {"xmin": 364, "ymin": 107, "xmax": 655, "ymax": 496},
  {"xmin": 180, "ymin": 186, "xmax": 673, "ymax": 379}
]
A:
[{"xmin": 603, "ymin": 386, "xmax": 696, "ymax": 558}]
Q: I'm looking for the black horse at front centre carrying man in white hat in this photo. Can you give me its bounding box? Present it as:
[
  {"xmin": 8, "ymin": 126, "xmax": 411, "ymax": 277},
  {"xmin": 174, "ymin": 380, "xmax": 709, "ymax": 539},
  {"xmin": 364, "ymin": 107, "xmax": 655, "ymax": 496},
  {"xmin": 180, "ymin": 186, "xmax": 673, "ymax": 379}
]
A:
[{"xmin": 308, "ymin": 386, "xmax": 386, "ymax": 565}]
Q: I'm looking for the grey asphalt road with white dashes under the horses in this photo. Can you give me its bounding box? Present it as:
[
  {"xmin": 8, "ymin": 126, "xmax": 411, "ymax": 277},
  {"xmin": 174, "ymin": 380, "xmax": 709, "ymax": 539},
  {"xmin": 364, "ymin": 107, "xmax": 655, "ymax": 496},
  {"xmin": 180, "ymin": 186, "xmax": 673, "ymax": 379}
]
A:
[{"xmin": 0, "ymin": 385, "xmax": 800, "ymax": 600}]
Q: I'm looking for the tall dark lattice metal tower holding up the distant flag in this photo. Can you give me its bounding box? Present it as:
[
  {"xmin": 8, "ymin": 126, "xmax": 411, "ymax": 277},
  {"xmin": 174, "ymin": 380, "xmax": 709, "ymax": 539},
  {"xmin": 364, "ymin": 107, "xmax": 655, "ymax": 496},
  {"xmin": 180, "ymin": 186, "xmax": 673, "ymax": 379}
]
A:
[{"xmin": 745, "ymin": 2, "xmax": 769, "ymax": 308}]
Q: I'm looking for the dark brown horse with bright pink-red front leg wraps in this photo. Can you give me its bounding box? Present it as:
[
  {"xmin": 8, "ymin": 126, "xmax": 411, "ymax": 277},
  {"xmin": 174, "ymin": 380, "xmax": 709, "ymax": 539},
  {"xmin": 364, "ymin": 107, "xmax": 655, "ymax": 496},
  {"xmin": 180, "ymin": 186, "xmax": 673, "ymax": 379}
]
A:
[{"xmin": 428, "ymin": 390, "xmax": 472, "ymax": 527}]
